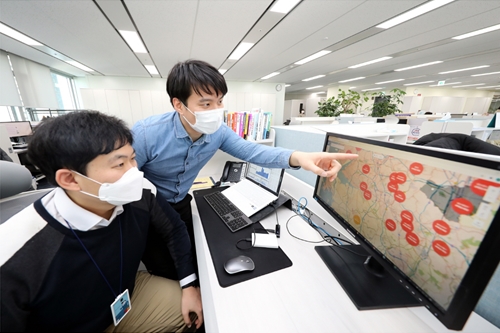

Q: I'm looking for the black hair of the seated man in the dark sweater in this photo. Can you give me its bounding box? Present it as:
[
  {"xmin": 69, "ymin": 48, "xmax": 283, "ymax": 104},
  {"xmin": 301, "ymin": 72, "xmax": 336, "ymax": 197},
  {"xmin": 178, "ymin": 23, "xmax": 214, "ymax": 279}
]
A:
[{"xmin": 27, "ymin": 111, "xmax": 133, "ymax": 186}]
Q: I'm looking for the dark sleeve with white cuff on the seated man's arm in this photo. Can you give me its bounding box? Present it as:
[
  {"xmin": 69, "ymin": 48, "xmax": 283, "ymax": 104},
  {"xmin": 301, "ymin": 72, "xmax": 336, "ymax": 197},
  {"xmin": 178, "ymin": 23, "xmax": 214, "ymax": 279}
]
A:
[{"xmin": 145, "ymin": 189, "xmax": 197, "ymax": 287}]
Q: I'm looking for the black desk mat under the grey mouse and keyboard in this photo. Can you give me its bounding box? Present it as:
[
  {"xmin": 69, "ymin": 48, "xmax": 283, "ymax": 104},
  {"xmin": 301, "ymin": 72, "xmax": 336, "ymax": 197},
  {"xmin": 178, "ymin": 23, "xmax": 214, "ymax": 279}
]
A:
[{"xmin": 193, "ymin": 188, "xmax": 292, "ymax": 288}]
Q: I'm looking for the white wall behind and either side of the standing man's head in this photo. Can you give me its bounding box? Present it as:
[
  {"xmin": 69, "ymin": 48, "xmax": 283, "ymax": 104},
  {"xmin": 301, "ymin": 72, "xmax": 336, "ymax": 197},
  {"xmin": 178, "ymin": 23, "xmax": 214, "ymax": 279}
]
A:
[{"xmin": 75, "ymin": 76, "xmax": 285, "ymax": 126}]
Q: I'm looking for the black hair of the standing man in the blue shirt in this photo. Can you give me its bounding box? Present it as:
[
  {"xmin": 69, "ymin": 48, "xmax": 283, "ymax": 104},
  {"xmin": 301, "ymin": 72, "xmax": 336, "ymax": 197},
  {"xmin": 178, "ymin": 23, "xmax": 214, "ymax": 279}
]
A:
[{"xmin": 167, "ymin": 60, "xmax": 227, "ymax": 105}]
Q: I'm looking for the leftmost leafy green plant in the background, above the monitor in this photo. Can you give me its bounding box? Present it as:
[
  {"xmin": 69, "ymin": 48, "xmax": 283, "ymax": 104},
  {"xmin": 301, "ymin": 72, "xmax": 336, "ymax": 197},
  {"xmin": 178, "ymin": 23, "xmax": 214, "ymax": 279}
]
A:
[{"xmin": 315, "ymin": 89, "xmax": 368, "ymax": 117}]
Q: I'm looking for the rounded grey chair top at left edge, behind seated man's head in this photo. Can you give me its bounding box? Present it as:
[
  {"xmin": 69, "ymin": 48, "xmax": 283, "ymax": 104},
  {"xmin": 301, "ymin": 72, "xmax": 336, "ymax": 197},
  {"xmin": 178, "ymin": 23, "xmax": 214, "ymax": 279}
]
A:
[{"xmin": 0, "ymin": 161, "xmax": 31, "ymax": 199}]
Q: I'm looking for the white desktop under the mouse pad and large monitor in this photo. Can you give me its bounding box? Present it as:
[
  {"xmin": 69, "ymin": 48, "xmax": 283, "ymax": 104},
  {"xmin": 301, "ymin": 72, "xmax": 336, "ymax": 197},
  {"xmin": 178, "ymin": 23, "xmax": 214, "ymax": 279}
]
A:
[{"xmin": 192, "ymin": 174, "xmax": 500, "ymax": 333}]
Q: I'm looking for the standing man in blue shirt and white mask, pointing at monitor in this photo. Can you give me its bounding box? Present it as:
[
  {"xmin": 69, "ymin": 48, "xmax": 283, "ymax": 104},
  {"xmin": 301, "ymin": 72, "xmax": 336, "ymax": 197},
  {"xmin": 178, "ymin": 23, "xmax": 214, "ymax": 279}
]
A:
[{"xmin": 132, "ymin": 60, "xmax": 357, "ymax": 276}]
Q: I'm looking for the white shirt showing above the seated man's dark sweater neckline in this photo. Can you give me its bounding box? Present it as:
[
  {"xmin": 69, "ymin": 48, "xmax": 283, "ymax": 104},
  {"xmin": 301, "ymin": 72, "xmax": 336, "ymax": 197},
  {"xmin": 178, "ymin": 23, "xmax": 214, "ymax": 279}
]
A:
[{"xmin": 42, "ymin": 187, "xmax": 123, "ymax": 231}]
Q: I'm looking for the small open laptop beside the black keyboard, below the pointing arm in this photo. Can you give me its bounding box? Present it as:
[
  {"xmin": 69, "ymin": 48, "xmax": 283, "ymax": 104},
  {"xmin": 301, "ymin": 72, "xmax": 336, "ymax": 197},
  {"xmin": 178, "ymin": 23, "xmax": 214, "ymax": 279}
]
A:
[{"xmin": 221, "ymin": 163, "xmax": 285, "ymax": 217}]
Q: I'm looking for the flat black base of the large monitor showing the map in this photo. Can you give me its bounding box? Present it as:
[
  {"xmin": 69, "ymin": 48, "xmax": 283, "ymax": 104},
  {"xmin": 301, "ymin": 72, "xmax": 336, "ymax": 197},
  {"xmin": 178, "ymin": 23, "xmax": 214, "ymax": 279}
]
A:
[{"xmin": 315, "ymin": 245, "xmax": 422, "ymax": 310}]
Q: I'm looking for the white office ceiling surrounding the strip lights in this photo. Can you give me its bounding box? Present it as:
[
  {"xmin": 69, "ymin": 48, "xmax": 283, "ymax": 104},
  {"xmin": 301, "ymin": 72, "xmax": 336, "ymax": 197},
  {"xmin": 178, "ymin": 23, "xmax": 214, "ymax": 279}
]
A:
[{"xmin": 0, "ymin": 0, "xmax": 500, "ymax": 93}]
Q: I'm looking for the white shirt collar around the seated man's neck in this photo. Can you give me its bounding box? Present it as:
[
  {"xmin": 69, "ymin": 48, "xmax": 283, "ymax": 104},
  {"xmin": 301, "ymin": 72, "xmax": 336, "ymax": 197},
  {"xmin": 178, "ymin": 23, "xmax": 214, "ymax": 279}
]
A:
[{"xmin": 54, "ymin": 187, "xmax": 123, "ymax": 231}]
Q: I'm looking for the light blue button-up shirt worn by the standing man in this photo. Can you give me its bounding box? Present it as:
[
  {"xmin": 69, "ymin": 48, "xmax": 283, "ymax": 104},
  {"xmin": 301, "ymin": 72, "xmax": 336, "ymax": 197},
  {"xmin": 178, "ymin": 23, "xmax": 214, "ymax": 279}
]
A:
[{"xmin": 132, "ymin": 111, "xmax": 293, "ymax": 203}]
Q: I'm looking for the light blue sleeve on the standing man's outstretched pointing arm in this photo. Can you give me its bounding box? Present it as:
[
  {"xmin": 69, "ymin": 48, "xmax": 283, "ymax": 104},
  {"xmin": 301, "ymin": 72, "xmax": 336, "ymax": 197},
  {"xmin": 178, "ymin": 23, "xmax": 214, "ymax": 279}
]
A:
[{"xmin": 220, "ymin": 125, "xmax": 296, "ymax": 169}]
